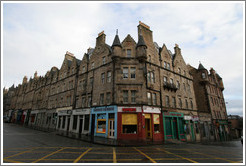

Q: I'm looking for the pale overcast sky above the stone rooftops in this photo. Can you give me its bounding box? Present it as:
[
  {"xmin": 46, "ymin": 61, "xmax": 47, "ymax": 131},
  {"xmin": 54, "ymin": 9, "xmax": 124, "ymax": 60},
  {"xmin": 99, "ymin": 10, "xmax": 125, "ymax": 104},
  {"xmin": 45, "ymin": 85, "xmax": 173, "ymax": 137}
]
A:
[{"xmin": 1, "ymin": 2, "xmax": 245, "ymax": 115}]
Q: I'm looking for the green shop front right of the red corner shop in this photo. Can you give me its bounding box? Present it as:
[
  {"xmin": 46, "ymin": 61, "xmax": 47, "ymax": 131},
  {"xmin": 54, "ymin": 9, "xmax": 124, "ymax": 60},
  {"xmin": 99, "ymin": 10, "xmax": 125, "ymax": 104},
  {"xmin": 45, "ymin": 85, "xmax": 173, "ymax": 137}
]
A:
[{"xmin": 163, "ymin": 112, "xmax": 186, "ymax": 141}]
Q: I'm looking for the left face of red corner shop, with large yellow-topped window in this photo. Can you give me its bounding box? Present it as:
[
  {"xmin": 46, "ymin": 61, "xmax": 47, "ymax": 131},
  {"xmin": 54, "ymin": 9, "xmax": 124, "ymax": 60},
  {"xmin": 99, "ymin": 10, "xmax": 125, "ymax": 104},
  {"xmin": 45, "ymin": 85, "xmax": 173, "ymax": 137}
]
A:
[{"xmin": 117, "ymin": 107, "xmax": 142, "ymax": 140}]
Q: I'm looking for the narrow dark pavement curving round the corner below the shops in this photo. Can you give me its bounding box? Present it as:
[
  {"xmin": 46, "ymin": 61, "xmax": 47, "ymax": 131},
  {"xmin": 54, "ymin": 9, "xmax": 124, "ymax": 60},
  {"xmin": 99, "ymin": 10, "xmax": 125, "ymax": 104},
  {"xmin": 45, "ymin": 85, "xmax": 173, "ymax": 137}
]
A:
[{"xmin": 56, "ymin": 131, "xmax": 181, "ymax": 147}]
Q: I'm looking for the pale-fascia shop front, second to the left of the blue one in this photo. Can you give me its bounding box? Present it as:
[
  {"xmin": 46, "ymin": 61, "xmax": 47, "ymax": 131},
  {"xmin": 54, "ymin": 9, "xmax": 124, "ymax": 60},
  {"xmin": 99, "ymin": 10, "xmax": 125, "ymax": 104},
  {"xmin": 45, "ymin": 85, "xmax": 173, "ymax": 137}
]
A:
[{"xmin": 56, "ymin": 107, "xmax": 72, "ymax": 132}]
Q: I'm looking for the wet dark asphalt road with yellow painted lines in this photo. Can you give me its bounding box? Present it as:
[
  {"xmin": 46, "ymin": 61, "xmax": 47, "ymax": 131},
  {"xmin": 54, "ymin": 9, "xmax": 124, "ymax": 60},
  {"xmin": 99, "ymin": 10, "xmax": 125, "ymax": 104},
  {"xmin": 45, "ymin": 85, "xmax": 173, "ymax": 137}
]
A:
[{"xmin": 3, "ymin": 123, "xmax": 243, "ymax": 163}]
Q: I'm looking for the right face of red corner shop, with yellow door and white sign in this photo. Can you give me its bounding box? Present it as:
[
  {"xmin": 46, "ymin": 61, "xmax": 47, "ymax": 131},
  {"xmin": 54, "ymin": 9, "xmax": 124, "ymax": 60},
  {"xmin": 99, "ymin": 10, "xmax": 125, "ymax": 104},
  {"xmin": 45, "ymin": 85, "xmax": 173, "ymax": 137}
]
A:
[{"xmin": 143, "ymin": 106, "xmax": 163, "ymax": 141}]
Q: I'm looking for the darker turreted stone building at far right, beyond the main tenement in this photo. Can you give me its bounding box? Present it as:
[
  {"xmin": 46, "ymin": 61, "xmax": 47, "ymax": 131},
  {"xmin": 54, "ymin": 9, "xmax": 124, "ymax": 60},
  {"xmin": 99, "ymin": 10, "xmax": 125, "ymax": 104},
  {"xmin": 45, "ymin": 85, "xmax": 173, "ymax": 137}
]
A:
[{"xmin": 190, "ymin": 63, "xmax": 229, "ymax": 141}]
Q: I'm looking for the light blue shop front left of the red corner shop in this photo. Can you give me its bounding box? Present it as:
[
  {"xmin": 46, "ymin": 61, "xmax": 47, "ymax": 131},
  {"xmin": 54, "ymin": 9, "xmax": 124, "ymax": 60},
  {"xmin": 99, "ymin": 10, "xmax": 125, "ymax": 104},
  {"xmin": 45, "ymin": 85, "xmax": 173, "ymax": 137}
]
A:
[{"xmin": 90, "ymin": 106, "xmax": 117, "ymax": 139}]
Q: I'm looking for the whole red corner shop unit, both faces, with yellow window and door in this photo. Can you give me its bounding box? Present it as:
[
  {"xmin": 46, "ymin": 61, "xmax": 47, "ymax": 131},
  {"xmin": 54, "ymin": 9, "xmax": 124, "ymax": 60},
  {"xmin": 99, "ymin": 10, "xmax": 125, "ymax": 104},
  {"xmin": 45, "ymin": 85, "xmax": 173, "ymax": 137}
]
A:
[{"xmin": 117, "ymin": 106, "xmax": 163, "ymax": 141}]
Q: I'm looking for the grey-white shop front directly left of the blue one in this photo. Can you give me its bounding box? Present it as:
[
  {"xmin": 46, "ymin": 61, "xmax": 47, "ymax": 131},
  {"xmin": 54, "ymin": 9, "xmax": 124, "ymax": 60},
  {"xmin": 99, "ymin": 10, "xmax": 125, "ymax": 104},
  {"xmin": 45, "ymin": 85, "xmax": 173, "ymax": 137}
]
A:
[{"xmin": 70, "ymin": 108, "xmax": 91, "ymax": 134}]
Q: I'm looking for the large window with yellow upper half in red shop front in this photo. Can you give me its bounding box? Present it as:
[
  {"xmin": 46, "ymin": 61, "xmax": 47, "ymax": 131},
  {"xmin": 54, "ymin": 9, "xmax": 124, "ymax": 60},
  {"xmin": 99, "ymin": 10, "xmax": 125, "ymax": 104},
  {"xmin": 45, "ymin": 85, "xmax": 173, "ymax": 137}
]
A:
[{"xmin": 122, "ymin": 114, "xmax": 137, "ymax": 134}]
